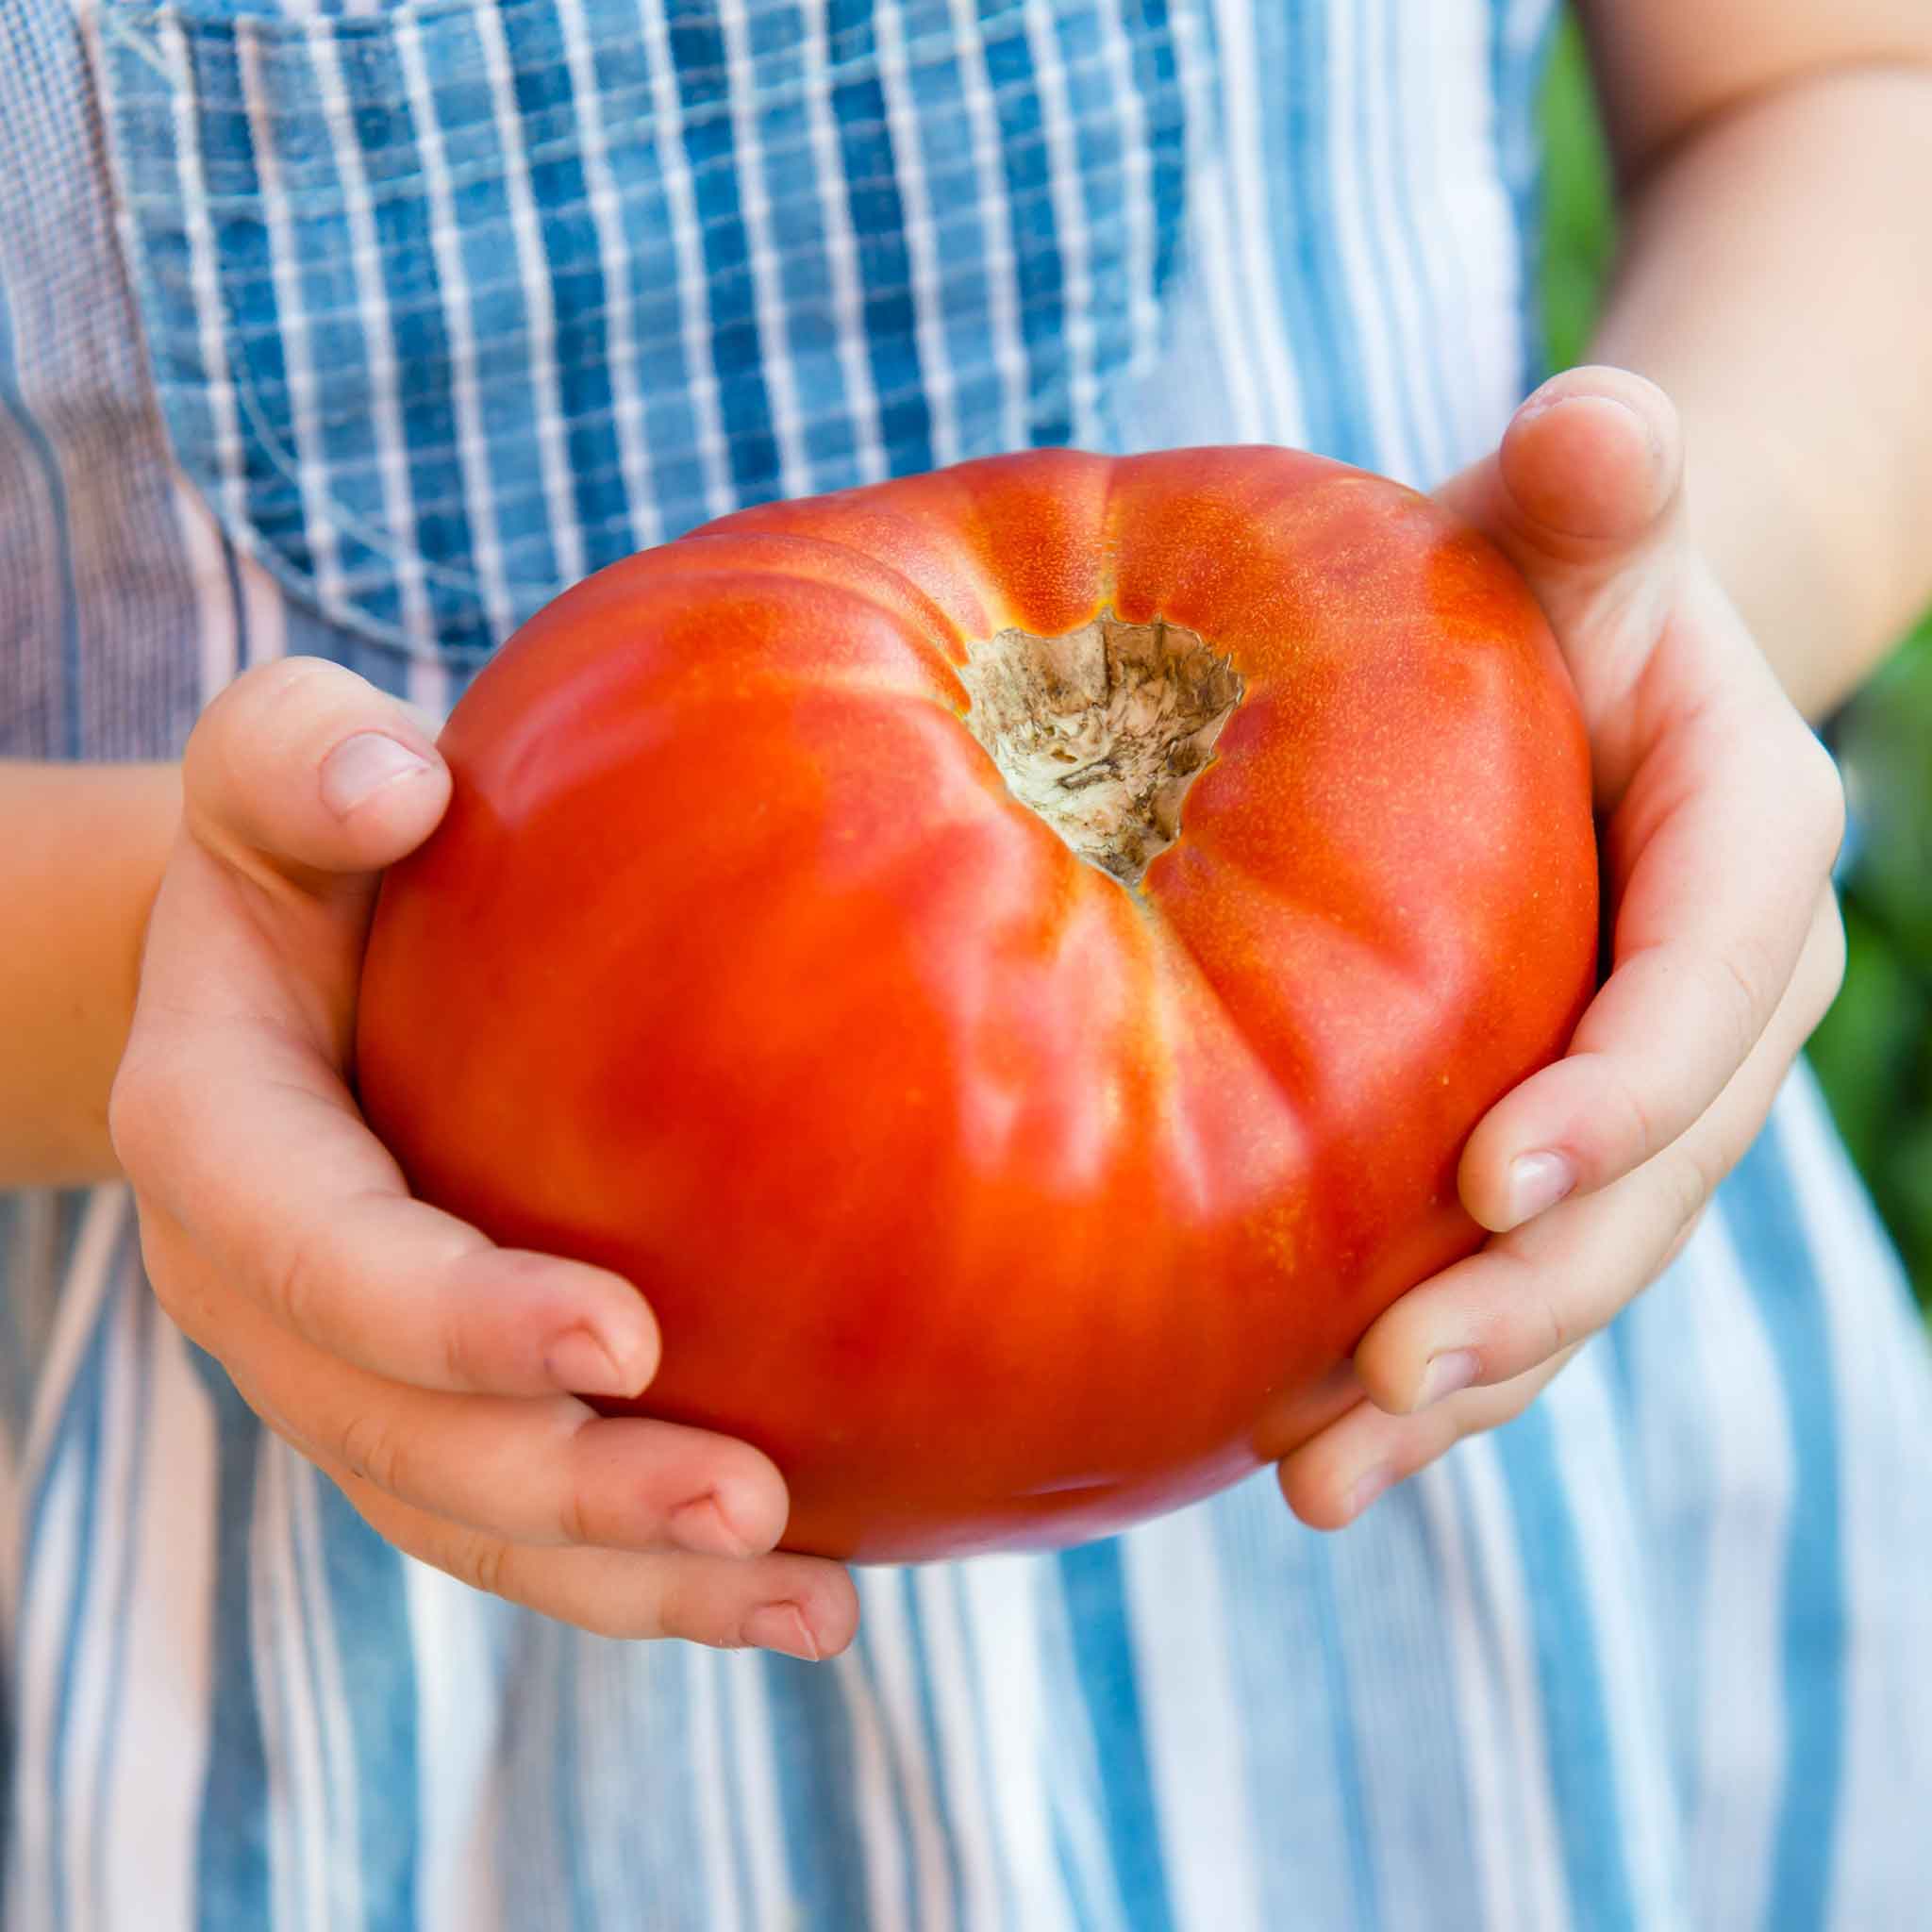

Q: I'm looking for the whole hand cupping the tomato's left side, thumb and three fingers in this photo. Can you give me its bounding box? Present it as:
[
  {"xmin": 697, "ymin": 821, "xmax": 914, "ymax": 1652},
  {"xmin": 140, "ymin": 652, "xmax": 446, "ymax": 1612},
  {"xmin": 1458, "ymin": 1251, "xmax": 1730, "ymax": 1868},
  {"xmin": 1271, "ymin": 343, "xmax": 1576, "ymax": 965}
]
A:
[{"xmin": 110, "ymin": 658, "xmax": 858, "ymax": 1656}]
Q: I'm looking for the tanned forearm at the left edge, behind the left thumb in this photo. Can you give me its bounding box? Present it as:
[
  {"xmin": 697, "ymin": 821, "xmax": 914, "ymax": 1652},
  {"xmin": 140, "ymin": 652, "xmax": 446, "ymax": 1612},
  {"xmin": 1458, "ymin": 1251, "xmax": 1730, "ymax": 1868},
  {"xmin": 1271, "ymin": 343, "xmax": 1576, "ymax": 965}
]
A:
[{"xmin": 0, "ymin": 761, "xmax": 182, "ymax": 1189}]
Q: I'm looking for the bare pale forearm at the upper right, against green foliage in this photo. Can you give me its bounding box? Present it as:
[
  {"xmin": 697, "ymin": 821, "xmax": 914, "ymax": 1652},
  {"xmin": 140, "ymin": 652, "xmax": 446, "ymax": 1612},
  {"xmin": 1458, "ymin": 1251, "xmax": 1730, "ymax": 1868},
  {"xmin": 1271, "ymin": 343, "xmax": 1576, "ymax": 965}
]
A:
[{"xmin": 1594, "ymin": 66, "xmax": 1932, "ymax": 719}]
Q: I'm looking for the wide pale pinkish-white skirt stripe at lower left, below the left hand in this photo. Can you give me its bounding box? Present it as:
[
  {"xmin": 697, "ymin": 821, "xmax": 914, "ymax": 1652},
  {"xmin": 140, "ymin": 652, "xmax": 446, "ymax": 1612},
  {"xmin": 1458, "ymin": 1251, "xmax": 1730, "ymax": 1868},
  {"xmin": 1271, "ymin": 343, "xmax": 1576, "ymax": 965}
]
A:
[{"xmin": 98, "ymin": 1321, "xmax": 217, "ymax": 1932}]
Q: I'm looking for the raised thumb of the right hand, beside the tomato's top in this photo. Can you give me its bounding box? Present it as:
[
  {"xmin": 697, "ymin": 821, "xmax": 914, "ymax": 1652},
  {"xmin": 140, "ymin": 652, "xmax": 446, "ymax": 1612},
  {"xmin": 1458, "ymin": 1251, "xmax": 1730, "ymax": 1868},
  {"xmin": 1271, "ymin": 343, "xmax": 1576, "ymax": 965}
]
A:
[{"xmin": 1436, "ymin": 367, "xmax": 1685, "ymax": 636}]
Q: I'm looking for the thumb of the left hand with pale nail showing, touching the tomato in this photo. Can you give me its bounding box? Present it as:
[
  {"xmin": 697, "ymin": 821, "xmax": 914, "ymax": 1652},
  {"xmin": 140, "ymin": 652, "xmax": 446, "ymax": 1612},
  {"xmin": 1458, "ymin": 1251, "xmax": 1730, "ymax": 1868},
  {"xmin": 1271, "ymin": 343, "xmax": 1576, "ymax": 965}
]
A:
[{"xmin": 182, "ymin": 657, "xmax": 450, "ymax": 885}]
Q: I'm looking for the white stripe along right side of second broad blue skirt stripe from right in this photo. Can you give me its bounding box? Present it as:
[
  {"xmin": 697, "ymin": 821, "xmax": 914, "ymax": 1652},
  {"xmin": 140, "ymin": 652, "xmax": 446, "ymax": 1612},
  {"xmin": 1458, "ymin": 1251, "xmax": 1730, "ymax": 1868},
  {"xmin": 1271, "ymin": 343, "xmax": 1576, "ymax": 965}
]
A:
[{"xmin": 1541, "ymin": 1342, "xmax": 1684, "ymax": 1926}]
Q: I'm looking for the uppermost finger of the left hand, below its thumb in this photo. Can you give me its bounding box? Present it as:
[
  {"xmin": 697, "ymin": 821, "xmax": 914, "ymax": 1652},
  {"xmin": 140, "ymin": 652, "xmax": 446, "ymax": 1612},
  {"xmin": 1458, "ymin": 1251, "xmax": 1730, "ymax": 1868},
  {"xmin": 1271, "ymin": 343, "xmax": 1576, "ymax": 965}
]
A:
[{"xmin": 114, "ymin": 1020, "xmax": 657, "ymax": 1395}]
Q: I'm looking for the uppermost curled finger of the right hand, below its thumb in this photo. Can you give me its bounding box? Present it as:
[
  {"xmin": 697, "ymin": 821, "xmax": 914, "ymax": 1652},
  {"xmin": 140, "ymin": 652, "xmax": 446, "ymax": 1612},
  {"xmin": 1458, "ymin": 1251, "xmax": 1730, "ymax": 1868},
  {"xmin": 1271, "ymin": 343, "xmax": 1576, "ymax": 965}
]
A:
[{"xmin": 1458, "ymin": 713, "xmax": 1843, "ymax": 1233}]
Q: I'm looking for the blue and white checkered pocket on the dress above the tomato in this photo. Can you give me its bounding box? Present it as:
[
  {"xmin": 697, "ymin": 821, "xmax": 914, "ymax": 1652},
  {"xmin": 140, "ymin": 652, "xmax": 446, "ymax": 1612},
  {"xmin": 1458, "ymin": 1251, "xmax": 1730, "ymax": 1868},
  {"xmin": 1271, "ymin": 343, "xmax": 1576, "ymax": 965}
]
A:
[{"xmin": 98, "ymin": 0, "xmax": 1211, "ymax": 660}]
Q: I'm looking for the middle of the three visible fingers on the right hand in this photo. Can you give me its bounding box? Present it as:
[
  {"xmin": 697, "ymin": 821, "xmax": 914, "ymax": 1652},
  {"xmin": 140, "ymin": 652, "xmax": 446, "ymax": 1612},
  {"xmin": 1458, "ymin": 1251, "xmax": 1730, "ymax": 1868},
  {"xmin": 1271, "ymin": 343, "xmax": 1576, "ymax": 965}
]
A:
[{"xmin": 1355, "ymin": 898, "xmax": 1843, "ymax": 1414}]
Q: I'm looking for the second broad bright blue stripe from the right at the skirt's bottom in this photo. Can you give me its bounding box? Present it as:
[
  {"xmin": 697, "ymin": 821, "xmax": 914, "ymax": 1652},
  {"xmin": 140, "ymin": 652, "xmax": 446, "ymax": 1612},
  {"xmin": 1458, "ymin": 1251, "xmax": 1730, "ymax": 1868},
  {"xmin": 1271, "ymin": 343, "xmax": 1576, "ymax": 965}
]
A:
[{"xmin": 1491, "ymin": 1405, "xmax": 1637, "ymax": 1932}]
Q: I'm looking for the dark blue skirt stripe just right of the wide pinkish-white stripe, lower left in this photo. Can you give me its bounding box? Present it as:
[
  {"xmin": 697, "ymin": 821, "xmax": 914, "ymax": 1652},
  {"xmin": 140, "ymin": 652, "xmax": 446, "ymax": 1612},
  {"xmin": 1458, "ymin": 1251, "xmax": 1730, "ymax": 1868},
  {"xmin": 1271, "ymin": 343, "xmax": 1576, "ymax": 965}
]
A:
[{"xmin": 193, "ymin": 1349, "xmax": 271, "ymax": 1926}]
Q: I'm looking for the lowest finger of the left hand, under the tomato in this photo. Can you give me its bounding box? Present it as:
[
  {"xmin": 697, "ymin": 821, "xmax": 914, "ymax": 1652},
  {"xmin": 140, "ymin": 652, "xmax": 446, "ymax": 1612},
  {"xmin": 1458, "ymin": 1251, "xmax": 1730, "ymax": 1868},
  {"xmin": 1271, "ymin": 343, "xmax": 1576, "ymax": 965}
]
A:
[{"xmin": 330, "ymin": 1471, "xmax": 858, "ymax": 1661}]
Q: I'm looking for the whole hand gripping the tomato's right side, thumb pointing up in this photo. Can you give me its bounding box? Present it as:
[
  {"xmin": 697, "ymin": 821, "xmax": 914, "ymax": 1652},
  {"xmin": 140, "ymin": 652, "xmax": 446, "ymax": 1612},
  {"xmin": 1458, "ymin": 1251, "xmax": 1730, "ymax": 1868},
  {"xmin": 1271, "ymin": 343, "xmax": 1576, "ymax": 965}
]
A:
[{"xmin": 1281, "ymin": 369, "xmax": 1845, "ymax": 1528}]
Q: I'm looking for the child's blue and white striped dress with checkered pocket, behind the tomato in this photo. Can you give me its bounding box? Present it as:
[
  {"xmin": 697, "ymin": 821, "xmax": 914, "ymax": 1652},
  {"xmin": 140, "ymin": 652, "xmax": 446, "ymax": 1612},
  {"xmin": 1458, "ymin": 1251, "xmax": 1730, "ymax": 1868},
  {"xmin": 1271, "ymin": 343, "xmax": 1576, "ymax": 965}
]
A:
[{"xmin": 0, "ymin": 0, "xmax": 1932, "ymax": 1932}]
